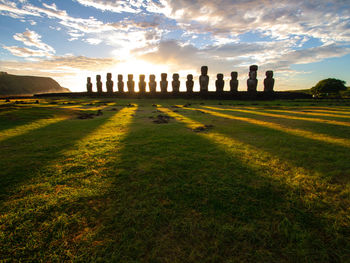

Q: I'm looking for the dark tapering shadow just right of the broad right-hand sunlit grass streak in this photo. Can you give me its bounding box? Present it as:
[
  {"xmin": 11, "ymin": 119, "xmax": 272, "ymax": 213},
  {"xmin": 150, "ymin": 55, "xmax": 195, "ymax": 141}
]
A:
[{"xmin": 181, "ymin": 106, "xmax": 350, "ymax": 184}]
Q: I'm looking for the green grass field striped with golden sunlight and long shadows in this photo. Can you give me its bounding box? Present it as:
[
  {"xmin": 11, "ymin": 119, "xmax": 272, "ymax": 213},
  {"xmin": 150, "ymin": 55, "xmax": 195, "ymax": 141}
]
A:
[{"xmin": 0, "ymin": 99, "xmax": 350, "ymax": 262}]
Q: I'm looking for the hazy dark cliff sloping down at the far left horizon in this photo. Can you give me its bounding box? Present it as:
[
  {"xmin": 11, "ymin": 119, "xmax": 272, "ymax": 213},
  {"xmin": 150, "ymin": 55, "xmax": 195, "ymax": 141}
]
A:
[{"xmin": 0, "ymin": 72, "xmax": 69, "ymax": 95}]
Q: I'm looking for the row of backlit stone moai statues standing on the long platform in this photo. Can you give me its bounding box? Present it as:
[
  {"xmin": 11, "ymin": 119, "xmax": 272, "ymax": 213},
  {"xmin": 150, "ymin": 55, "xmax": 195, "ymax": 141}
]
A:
[{"xmin": 86, "ymin": 65, "xmax": 275, "ymax": 93}]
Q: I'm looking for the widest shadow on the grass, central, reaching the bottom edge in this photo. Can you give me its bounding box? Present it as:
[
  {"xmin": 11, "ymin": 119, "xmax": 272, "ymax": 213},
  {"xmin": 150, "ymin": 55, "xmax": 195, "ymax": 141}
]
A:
[{"xmin": 80, "ymin": 106, "xmax": 345, "ymax": 262}]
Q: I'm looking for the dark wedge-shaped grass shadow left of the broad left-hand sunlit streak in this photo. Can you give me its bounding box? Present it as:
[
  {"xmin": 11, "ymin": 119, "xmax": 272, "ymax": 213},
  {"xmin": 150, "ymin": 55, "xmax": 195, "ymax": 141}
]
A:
[{"xmin": 0, "ymin": 109, "xmax": 120, "ymax": 200}]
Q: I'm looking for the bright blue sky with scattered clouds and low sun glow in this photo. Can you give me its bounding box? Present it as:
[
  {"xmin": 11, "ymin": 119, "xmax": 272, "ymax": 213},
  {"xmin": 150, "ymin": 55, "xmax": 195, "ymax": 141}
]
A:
[{"xmin": 0, "ymin": 0, "xmax": 350, "ymax": 91}]
